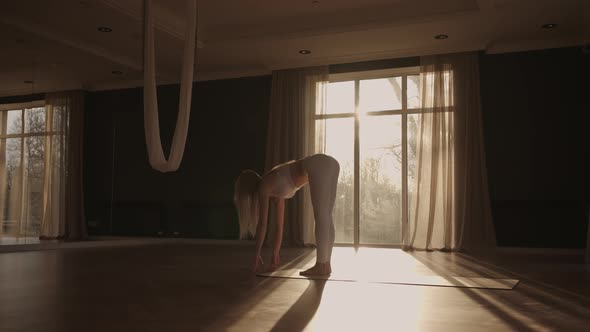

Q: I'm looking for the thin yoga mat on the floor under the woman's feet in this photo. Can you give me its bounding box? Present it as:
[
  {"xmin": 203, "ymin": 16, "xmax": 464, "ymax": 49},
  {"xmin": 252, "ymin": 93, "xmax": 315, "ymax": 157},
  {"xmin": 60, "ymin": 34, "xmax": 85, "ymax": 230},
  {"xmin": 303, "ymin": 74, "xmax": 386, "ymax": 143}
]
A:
[{"xmin": 257, "ymin": 269, "xmax": 519, "ymax": 289}]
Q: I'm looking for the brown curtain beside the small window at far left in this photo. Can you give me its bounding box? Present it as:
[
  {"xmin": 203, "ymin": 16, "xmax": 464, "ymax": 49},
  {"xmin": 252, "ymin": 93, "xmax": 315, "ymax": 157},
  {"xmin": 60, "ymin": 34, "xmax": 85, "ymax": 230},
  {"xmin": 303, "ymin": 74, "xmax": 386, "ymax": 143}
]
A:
[{"xmin": 40, "ymin": 91, "xmax": 87, "ymax": 240}]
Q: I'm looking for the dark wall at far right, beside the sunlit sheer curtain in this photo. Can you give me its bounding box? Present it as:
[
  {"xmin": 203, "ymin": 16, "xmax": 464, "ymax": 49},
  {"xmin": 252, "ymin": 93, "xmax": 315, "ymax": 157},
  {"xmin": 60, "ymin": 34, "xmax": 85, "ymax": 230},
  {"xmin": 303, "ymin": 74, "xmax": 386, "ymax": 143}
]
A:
[{"xmin": 480, "ymin": 47, "xmax": 590, "ymax": 248}]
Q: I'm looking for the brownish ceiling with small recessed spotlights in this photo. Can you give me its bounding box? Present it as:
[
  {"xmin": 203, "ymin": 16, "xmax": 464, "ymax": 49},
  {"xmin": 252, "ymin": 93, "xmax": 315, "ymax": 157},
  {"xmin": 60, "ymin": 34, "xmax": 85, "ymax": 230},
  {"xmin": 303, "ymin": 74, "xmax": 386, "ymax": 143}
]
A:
[{"xmin": 0, "ymin": 0, "xmax": 590, "ymax": 96}]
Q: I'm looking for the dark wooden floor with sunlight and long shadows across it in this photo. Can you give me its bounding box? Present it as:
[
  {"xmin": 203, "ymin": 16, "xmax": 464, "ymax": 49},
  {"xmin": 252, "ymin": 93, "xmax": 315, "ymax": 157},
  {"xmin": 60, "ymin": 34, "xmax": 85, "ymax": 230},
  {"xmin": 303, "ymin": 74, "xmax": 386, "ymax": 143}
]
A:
[{"xmin": 0, "ymin": 243, "xmax": 590, "ymax": 332}]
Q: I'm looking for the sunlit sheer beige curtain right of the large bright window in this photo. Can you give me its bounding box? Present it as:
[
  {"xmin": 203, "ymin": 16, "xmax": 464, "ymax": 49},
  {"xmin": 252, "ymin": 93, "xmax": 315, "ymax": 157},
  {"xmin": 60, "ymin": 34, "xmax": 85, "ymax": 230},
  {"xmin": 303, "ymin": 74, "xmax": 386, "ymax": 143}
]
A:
[{"xmin": 404, "ymin": 53, "xmax": 495, "ymax": 250}]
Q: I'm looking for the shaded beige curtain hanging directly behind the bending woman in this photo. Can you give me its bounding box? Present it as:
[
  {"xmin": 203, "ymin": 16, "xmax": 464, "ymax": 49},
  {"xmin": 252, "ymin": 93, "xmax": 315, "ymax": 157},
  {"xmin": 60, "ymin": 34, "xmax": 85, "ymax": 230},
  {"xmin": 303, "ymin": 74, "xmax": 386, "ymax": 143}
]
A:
[{"xmin": 265, "ymin": 67, "xmax": 328, "ymax": 246}]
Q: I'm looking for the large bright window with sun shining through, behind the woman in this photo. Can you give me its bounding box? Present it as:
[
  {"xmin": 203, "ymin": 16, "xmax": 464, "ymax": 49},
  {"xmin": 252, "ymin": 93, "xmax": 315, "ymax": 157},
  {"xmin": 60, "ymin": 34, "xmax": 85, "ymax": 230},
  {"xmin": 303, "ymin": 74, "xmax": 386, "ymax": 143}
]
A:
[{"xmin": 316, "ymin": 67, "xmax": 421, "ymax": 245}]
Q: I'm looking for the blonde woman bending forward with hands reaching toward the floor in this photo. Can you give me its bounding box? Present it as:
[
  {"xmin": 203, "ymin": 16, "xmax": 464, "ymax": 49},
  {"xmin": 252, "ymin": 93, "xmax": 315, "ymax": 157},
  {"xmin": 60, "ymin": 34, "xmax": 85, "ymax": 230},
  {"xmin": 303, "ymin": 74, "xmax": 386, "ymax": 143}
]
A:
[{"xmin": 234, "ymin": 154, "xmax": 340, "ymax": 276}]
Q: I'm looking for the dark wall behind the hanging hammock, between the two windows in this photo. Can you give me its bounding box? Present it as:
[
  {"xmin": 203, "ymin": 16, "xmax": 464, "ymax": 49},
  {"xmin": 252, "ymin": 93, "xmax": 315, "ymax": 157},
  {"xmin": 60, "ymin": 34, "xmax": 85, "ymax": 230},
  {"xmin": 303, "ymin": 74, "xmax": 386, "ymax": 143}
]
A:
[{"xmin": 84, "ymin": 76, "xmax": 271, "ymax": 238}]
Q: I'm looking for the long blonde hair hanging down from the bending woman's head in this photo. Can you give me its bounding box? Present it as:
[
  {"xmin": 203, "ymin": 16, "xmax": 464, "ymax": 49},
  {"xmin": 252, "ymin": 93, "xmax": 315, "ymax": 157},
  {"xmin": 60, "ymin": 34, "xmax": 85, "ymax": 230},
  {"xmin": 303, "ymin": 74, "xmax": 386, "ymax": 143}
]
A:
[{"xmin": 234, "ymin": 170, "xmax": 261, "ymax": 240}]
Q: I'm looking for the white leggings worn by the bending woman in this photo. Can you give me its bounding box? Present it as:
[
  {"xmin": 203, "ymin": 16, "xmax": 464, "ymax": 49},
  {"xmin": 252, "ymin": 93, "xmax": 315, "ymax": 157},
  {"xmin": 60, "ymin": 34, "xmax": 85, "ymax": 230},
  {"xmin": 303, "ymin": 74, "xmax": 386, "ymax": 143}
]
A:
[{"xmin": 303, "ymin": 154, "xmax": 340, "ymax": 263}]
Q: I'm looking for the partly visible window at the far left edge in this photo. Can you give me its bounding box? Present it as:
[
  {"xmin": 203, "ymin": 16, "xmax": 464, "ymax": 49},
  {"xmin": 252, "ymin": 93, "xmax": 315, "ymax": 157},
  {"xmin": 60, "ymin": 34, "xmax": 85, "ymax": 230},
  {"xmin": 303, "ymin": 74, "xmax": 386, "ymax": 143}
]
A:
[{"xmin": 0, "ymin": 101, "xmax": 48, "ymax": 237}]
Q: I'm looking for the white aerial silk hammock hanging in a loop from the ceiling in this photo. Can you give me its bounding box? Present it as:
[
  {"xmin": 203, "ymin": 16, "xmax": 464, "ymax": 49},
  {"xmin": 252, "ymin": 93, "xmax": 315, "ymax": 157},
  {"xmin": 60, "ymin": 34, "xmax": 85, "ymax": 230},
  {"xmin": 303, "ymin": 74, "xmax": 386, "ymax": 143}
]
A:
[{"xmin": 143, "ymin": 0, "xmax": 197, "ymax": 173}]
